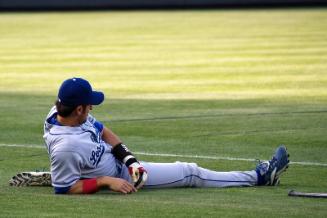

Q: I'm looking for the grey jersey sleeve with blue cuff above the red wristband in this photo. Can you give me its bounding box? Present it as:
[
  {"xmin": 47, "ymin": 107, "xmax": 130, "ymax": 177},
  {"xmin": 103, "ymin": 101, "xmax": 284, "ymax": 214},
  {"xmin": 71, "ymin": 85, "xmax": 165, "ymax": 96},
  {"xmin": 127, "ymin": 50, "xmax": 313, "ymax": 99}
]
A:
[{"xmin": 51, "ymin": 151, "xmax": 83, "ymax": 194}]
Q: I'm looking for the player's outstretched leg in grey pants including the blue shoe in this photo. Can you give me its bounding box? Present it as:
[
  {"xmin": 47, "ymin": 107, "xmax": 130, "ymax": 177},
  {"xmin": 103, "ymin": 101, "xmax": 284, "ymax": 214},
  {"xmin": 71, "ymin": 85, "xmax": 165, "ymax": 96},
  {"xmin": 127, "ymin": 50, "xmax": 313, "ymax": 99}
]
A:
[{"xmin": 121, "ymin": 146, "xmax": 289, "ymax": 188}]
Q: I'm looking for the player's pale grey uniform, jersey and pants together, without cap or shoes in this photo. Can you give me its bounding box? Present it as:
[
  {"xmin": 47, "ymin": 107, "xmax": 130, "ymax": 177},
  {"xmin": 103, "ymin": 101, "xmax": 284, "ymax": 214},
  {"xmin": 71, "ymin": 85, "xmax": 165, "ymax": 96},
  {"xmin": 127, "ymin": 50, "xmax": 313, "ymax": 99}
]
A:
[{"xmin": 43, "ymin": 107, "xmax": 258, "ymax": 194}]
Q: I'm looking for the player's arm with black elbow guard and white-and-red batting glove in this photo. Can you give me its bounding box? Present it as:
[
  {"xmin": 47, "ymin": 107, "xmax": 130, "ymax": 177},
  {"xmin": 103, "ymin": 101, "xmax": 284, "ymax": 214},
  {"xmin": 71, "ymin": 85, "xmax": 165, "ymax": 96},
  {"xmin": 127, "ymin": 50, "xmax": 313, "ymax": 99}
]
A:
[{"xmin": 102, "ymin": 127, "xmax": 148, "ymax": 189}]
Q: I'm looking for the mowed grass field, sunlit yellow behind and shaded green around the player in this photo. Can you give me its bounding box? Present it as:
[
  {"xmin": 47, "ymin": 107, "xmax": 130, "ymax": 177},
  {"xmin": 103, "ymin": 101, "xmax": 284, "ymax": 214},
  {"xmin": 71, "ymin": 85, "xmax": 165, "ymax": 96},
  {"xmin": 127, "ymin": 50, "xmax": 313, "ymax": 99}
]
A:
[{"xmin": 0, "ymin": 8, "xmax": 327, "ymax": 218}]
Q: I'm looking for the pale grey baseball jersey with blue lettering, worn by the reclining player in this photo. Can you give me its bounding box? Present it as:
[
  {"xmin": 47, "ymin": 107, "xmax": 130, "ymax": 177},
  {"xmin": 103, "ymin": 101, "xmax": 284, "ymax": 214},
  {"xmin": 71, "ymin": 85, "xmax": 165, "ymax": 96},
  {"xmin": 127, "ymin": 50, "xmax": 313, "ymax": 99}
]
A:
[{"xmin": 43, "ymin": 107, "xmax": 118, "ymax": 193}]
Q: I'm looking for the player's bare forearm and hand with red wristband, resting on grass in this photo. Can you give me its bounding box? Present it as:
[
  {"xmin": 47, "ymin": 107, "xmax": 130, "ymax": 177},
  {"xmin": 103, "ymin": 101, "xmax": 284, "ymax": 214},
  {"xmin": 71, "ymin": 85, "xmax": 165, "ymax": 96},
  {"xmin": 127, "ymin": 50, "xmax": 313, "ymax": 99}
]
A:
[{"xmin": 68, "ymin": 176, "xmax": 137, "ymax": 194}]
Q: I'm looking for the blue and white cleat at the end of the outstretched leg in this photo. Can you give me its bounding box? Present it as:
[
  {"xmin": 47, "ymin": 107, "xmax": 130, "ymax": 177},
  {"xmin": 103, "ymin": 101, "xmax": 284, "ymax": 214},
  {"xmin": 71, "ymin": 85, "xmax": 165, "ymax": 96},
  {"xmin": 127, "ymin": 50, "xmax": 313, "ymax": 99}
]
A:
[{"xmin": 255, "ymin": 145, "xmax": 290, "ymax": 185}]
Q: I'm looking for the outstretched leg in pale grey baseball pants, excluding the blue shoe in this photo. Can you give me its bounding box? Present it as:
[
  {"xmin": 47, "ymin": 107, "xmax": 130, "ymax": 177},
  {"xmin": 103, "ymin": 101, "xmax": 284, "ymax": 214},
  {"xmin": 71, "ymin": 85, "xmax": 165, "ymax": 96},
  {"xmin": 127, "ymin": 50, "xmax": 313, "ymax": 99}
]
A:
[{"xmin": 118, "ymin": 162, "xmax": 257, "ymax": 188}]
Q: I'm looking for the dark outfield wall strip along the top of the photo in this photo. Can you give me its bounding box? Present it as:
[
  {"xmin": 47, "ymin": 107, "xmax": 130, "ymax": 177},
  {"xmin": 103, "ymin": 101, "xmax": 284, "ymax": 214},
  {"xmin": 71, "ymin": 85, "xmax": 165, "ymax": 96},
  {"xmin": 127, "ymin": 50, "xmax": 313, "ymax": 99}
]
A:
[{"xmin": 0, "ymin": 0, "xmax": 327, "ymax": 10}]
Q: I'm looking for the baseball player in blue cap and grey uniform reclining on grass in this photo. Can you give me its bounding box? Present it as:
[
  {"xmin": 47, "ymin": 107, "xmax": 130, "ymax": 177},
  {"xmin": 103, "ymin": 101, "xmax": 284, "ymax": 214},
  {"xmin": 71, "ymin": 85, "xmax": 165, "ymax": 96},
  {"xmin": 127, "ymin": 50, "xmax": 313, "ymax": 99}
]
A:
[{"xmin": 10, "ymin": 78, "xmax": 289, "ymax": 194}]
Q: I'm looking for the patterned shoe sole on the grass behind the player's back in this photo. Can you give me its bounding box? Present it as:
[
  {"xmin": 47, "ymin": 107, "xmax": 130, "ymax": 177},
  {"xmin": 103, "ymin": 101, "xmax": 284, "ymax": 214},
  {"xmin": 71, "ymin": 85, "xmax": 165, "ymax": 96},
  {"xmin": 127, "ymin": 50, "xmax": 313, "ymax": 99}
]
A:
[{"xmin": 9, "ymin": 172, "xmax": 51, "ymax": 186}]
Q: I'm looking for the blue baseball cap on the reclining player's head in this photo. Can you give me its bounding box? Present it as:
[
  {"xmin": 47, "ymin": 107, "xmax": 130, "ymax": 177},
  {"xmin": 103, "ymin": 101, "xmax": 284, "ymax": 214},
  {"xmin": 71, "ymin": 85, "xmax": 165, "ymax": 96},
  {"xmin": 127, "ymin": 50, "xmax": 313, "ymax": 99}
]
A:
[{"xmin": 58, "ymin": 78, "xmax": 104, "ymax": 106}]
